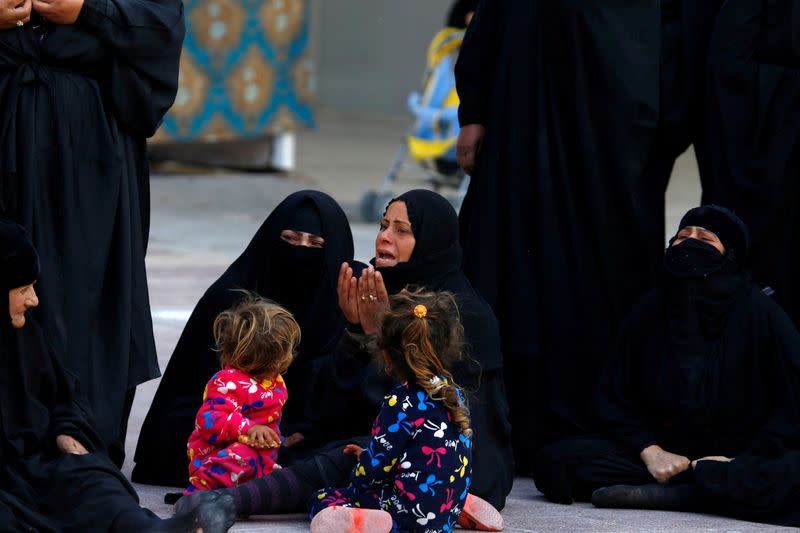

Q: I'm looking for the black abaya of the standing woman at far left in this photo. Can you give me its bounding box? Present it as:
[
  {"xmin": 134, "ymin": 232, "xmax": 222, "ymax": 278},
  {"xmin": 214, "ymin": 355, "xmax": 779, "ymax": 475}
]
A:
[{"xmin": 0, "ymin": 0, "xmax": 184, "ymax": 461}]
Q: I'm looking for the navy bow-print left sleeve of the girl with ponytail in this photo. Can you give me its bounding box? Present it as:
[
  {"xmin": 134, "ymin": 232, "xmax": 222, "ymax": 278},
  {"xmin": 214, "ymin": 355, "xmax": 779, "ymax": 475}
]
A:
[{"xmin": 350, "ymin": 394, "xmax": 412, "ymax": 489}]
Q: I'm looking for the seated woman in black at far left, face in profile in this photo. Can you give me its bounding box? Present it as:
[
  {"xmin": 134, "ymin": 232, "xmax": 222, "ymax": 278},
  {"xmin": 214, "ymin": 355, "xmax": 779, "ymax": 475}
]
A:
[{"xmin": 0, "ymin": 222, "xmax": 234, "ymax": 533}]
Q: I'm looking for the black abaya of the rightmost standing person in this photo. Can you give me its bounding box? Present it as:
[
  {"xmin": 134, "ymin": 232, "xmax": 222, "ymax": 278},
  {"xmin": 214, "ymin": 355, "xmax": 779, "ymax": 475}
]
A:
[{"xmin": 697, "ymin": 0, "xmax": 800, "ymax": 327}]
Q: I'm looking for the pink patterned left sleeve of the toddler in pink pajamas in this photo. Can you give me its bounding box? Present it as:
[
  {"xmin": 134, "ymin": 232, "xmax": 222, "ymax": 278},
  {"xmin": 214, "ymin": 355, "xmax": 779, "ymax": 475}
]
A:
[{"xmin": 195, "ymin": 370, "xmax": 253, "ymax": 444}]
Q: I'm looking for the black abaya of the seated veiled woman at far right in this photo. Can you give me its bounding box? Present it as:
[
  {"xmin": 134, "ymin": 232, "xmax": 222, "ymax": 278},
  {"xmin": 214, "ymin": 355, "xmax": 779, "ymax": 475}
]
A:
[{"xmin": 535, "ymin": 279, "xmax": 800, "ymax": 525}]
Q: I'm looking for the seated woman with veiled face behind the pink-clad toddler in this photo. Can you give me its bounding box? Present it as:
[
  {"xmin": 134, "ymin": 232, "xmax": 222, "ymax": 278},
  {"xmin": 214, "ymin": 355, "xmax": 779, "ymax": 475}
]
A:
[{"xmin": 132, "ymin": 191, "xmax": 353, "ymax": 488}]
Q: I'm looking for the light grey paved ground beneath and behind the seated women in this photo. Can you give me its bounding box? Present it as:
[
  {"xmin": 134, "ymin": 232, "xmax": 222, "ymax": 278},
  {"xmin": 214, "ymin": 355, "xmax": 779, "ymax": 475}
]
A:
[{"xmin": 124, "ymin": 110, "xmax": 788, "ymax": 533}]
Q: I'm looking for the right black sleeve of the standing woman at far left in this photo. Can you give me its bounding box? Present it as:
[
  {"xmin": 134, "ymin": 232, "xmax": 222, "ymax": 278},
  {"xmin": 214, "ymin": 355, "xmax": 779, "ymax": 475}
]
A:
[{"xmin": 76, "ymin": 0, "xmax": 184, "ymax": 137}]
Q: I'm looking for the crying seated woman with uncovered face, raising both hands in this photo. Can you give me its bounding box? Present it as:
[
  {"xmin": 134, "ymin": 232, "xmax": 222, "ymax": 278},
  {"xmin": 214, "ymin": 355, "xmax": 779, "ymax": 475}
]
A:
[{"xmin": 176, "ymin": 190, "xmax": 514, "ymax": 530}]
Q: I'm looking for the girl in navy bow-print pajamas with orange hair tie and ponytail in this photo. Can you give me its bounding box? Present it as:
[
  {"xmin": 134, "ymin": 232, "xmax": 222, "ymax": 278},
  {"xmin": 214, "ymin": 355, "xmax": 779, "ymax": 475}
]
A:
[{"xmin": 311, "ymin": 290, "xmax": 472, "ymax": 533}]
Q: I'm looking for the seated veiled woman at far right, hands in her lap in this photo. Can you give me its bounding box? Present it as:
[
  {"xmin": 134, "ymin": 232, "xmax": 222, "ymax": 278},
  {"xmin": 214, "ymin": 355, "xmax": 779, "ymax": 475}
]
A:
[{"xmin": 534, "ymin": 206, "xmax": 800, "ymax": 525}]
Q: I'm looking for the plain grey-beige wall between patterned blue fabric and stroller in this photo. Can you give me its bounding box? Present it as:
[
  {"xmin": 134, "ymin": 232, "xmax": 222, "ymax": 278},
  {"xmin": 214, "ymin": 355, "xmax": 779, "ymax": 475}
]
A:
[{"xmin": 313, "ymin": 0, "xmax": 451, "ymax": 114}]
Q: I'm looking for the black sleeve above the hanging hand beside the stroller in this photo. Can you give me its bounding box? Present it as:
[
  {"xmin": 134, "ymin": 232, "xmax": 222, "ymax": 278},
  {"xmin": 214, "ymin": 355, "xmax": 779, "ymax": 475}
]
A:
[{"xmin": 455, "ymin": 0, "xmax": 505, "ymax": 127}]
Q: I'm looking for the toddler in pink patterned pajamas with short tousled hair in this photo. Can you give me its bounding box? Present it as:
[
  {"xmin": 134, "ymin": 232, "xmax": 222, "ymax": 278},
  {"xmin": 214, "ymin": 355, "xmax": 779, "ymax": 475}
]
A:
[{"xmin": 184, "ymin": 296, "xmax": 300, "ymax": 494}]
